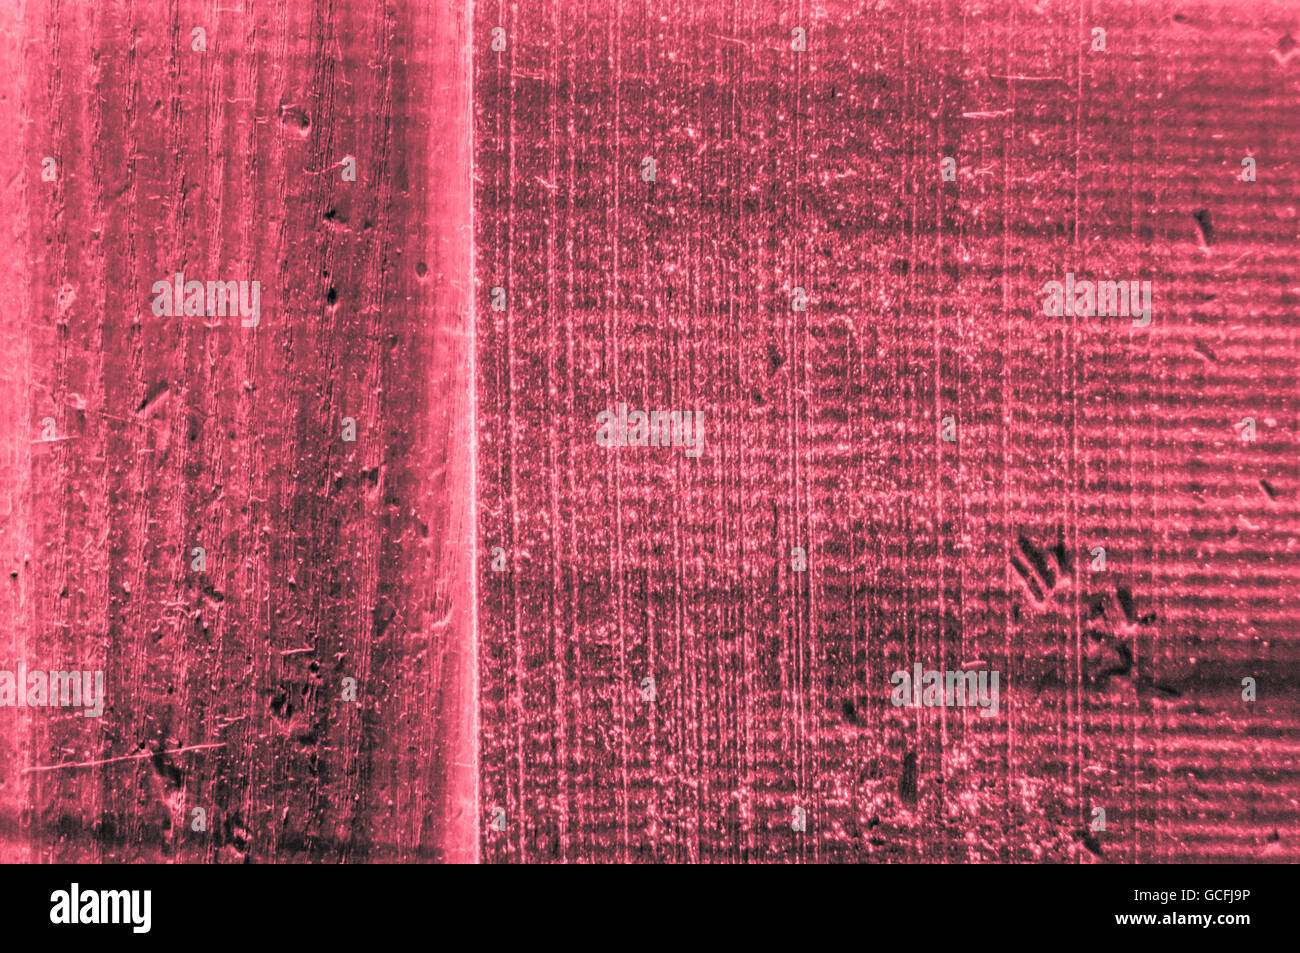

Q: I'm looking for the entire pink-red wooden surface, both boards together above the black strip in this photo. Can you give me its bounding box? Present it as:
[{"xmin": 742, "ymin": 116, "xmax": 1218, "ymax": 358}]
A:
[{"xmin": 0, "ymin": 0, "xmax": 1300, "ymax": 862}]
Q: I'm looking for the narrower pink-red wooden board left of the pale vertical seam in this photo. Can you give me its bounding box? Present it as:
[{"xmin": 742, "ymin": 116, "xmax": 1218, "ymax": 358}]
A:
[{"xmin": 0, "ymin": 0, "xmax": 478, "ymax": 862}]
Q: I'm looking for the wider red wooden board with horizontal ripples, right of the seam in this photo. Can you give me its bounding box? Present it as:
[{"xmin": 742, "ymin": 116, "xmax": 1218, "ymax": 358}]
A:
[{"xmin": 475, "ymin": 0, "xmax": 1300, "ymax": 862}]
